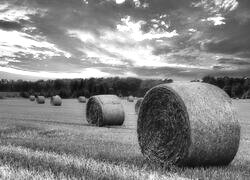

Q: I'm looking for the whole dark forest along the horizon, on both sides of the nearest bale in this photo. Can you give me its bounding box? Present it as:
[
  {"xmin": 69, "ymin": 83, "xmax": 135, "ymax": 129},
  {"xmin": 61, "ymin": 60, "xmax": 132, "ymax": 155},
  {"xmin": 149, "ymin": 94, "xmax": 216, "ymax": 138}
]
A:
[{"xmin": 0, "ymin": 76, "xmax": 250, "ymax": 98}]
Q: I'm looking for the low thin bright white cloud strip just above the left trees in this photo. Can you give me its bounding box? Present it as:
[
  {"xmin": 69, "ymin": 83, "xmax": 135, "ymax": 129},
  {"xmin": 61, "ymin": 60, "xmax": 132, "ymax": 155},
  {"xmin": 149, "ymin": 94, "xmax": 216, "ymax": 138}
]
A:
[{"xmin": 0, "ymin": 66, "xmax": 110, "ymax": 79}]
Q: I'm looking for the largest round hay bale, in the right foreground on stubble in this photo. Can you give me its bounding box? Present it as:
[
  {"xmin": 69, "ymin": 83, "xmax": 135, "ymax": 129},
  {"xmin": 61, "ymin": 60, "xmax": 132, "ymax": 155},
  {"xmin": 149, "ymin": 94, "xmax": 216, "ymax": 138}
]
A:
[{"xmin": 137, "ymin": 83, "xmax": 240, "ymax": 166}]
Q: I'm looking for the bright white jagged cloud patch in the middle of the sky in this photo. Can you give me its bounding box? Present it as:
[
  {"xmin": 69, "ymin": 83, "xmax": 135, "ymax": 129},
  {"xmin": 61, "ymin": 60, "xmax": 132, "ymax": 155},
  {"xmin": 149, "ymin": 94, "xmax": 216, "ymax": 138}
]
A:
[{"xmin": 68, "ymin": 16, "xmax": 181, "ymax": 67}]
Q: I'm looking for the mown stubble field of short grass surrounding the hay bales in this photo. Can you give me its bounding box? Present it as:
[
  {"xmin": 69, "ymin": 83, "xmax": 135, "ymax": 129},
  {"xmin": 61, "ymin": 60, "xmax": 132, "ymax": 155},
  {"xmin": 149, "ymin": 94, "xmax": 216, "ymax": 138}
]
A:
[{"xmin": 0, "ymin": 99, "xmax": 250, "ymax": 179}]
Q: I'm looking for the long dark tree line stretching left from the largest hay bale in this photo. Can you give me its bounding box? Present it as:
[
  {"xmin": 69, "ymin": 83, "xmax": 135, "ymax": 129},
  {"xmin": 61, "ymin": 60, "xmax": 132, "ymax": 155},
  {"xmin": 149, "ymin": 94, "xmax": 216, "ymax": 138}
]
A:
[{"xmin": 0, "ymin": 77, "xmax": 173, "ymax": 98}]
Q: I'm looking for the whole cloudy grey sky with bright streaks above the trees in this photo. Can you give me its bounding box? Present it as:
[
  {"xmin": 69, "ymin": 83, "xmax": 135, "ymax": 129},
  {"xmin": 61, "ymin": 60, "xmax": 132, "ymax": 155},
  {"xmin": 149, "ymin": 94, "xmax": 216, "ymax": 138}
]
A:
[{"xmin": 0, "ymin": 0, "xmax": 250, "ymax": 80}]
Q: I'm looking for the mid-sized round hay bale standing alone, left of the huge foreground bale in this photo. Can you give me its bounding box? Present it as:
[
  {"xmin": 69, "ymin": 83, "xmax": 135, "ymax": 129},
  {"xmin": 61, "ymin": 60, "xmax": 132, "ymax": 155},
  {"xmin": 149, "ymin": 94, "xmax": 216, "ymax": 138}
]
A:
[{"xmin": 86, "ymin": 95, "xmax": 125, "ymax": 126}]
